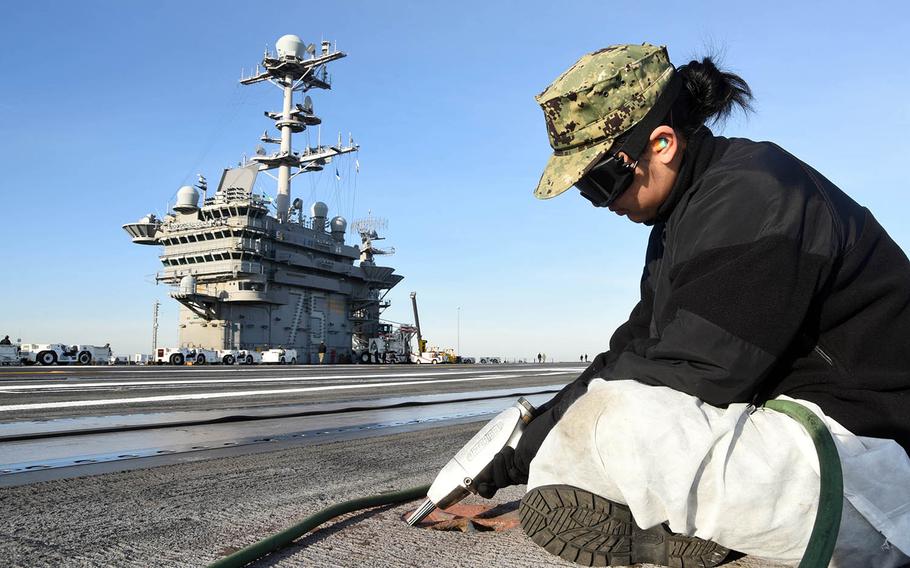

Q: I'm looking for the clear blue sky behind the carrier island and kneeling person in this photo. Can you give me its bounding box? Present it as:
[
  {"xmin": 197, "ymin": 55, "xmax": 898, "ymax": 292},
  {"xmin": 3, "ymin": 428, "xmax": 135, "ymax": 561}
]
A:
[{"xmin": 0, "ymin": 1, "xmax": 910, "ymax": 360}]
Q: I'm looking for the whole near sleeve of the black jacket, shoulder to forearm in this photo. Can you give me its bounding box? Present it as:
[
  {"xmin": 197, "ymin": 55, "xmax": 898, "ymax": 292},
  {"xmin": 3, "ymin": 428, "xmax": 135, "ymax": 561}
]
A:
[{"xmin": 598, "ymin": 162, "xmax": 838, "ymax": 406}]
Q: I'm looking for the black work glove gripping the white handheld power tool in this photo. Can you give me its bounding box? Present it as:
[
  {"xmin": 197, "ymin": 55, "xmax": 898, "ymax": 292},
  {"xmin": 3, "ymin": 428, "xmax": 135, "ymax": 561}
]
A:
[{"xmin": 474, "ymin": 408, "xmax": 557, "ymax": 499}]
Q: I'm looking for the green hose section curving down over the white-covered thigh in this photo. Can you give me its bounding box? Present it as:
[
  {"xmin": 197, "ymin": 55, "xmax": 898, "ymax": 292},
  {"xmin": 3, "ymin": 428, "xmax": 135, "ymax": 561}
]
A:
[{"xmin": 765, "ymin": 400, "xmax": 844, "ymax": 568}]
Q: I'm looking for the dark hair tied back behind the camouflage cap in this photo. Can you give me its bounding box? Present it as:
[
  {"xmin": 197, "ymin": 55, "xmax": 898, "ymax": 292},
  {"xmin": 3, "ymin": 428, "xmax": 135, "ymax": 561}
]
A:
[{"xmin": 664, "ymin": 57, "xmax": 752, "ymax": 138}]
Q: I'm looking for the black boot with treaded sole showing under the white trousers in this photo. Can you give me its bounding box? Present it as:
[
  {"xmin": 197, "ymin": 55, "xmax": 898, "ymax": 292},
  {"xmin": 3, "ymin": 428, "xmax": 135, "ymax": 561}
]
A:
[{"xmin": 518, "ymin": 485, "xmax": 729, "ymax": 568}]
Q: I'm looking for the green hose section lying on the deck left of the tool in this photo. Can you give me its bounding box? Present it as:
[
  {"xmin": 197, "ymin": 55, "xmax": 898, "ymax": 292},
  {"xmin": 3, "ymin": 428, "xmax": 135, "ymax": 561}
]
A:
[{"xmin": 209, "ymin": 485, "xmax": 430, "ymax": 568}]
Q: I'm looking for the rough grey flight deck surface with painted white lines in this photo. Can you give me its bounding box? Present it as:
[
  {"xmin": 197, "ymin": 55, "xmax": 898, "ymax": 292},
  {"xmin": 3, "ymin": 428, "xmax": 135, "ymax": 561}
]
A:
[{"xmin": 0, "ymin": 365, "xmax": 784, "ymax": 567}]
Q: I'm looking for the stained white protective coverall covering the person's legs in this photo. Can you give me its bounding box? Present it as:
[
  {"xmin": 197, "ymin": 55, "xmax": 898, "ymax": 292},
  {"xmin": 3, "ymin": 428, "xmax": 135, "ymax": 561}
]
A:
[{"xmin": 528, "ymin": 379, "xmax": 910, "ymax": 568}]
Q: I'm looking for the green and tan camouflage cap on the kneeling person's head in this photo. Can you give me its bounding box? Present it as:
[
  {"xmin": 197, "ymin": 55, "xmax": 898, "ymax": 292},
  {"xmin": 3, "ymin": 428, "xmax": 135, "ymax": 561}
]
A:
[{"xmin": 534, "ymin": 43, "xmax": 675, "ymax": 199}]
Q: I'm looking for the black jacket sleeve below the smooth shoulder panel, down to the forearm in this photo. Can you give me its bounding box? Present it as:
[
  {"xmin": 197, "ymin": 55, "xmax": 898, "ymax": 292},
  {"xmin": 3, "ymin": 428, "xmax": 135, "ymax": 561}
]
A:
[{"xmin": 602, "ymin": 233, "xmax": 828, "ymax": 406}]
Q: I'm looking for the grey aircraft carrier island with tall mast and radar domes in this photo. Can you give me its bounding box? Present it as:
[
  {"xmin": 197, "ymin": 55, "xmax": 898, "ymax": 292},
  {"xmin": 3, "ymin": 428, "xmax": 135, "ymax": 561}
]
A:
[{"xmin": 123, "ymin": 35, "xmax": 402, "ymax": 362}]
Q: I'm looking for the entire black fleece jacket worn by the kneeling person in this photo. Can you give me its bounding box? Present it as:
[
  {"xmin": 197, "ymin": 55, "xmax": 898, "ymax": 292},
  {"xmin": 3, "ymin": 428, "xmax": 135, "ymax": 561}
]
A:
[{"xmin": 528, "ymin": 131, "xmax": 910, "ymax": 461}]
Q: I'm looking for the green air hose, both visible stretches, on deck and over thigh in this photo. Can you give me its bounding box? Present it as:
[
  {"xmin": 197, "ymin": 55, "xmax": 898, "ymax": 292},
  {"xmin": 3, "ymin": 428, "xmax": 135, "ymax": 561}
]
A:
[{"xmin": 209, "ymin": 400, "xmax": 844, "ymax": 568}]
